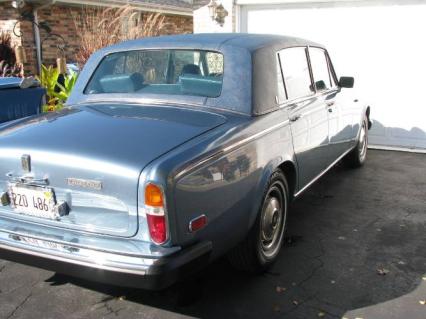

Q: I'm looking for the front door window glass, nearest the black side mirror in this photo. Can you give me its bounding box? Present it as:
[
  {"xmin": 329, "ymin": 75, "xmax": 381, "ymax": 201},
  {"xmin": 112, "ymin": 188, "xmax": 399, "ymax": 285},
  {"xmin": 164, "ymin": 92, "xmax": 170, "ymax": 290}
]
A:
[{"xmin": 309, "ymin": 48, "xmax": 332, "ymax": 91}]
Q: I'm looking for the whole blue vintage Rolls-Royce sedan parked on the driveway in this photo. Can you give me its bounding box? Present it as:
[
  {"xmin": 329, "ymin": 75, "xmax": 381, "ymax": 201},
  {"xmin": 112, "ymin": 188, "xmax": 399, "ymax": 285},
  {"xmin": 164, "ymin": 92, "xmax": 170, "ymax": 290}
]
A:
[{"xmin": 0, "ymin": 34, "xmax": 371, "ymax": 290}]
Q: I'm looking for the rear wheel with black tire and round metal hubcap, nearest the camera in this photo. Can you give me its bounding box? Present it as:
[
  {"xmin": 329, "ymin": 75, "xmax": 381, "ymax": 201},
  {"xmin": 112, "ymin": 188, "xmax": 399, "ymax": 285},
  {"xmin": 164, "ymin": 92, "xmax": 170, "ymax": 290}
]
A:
[{"xmin": 228, "ymin": 170, "xmax": 289, "ymax": 274}]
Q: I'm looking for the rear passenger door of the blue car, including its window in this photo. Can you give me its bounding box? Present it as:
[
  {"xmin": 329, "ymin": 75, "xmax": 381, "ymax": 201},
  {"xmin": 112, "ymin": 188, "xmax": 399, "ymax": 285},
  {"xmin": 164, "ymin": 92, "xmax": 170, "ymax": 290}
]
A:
[{"xmin": 279, "ymin": 47, "xmax": 329, "ymax": 189}]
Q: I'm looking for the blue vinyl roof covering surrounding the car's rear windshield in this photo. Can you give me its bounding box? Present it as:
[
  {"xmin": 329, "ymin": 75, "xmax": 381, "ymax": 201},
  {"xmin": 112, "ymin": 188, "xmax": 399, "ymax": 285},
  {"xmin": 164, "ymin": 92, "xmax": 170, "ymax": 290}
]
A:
[{"xmin": 69, "ymin": 33, "xmax": 322, "ymax": 116}]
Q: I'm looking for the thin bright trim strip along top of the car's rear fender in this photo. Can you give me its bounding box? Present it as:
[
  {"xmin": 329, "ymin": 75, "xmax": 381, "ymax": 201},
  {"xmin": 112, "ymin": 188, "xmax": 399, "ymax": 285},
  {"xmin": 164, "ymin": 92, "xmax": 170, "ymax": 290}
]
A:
[{"xmin": 174, "ymin": 120, "xmax": 289, "ymax": 179}]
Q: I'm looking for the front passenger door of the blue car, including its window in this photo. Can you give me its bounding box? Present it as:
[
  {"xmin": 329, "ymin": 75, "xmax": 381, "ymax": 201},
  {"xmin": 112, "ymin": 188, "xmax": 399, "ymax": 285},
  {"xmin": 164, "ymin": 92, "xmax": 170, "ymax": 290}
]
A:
[{"xmin": 309, "ymin": 47, "xmax": 353, "ymax": 165}]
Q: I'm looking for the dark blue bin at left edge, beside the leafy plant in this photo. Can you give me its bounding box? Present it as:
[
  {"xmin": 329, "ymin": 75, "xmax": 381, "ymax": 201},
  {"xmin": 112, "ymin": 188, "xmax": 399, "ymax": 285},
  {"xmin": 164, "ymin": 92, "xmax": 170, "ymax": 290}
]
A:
[{"xmin": 0, "ymin": 78, "xmax": 46, "ymax": 123}]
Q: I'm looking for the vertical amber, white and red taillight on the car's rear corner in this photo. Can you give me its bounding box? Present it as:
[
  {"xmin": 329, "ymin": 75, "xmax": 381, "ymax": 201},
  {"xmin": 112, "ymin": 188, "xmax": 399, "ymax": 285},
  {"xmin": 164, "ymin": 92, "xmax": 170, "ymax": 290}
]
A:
[{"xmin": 145, "ymin": 184, "xmax": 167, "ymax": 245}]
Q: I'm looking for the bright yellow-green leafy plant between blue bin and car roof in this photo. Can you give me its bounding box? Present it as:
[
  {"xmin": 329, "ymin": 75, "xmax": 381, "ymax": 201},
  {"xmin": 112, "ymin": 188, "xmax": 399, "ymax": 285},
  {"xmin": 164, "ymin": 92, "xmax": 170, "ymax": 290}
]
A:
[{"xmin": 37, "ymin": 65, "xmax": 78, "ymax": 112}]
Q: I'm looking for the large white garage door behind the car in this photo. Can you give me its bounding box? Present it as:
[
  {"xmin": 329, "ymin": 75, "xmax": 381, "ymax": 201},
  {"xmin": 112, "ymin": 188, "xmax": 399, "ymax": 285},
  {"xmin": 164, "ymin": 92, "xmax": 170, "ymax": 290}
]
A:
[{"xmin": 240, "ymin": 0, "xmax": 426, "ymax": 149}]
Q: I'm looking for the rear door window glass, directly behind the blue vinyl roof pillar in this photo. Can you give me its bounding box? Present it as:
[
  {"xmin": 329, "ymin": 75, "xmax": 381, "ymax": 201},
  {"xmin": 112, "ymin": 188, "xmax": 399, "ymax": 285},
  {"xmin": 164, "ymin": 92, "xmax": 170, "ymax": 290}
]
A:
[{"xmin": 279, "ymin": 47, "xmax": 314, "ymax": 100}]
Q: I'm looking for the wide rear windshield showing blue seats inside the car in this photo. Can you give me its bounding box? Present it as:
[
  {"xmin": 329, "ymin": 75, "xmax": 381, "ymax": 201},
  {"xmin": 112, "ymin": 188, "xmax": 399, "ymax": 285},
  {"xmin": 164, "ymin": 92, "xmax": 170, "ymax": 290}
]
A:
[{"xmin": 84, "ymin": 50, "xmax": 223, "ymax": 97}]
